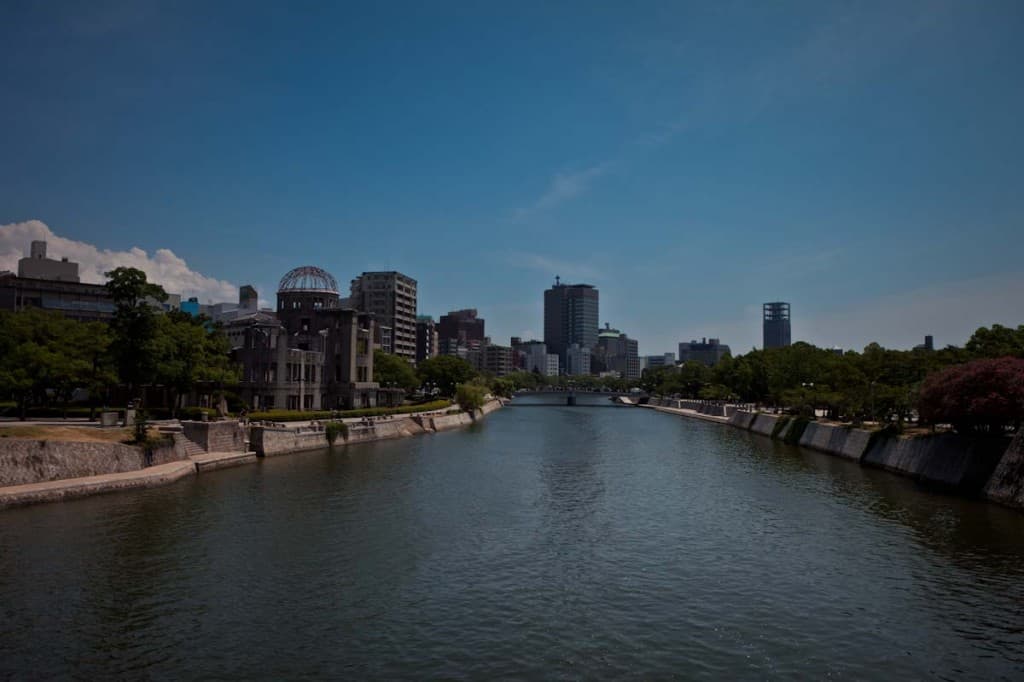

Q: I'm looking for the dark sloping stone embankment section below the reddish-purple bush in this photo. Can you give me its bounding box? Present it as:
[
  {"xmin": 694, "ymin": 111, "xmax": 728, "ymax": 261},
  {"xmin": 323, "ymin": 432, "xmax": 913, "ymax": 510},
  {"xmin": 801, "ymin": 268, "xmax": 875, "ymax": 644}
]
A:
[{"xmin": 861, "ymin": 433, "xmax": 1007, "ymax": 495}]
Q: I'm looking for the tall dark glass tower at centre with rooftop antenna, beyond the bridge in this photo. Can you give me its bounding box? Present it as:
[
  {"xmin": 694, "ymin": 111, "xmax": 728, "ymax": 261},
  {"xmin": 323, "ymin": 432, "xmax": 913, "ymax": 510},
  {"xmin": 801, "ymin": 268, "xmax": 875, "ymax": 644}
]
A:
[{"xmin": 544, "ymin": 278, "xmax": 598, "ymax": 373}]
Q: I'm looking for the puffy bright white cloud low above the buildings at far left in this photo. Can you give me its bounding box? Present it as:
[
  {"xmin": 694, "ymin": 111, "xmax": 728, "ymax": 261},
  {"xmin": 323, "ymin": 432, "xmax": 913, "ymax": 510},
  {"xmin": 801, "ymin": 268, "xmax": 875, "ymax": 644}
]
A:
[{"xmin": 0, "ymin": 220, "xmax": 239, "ymax": 302}]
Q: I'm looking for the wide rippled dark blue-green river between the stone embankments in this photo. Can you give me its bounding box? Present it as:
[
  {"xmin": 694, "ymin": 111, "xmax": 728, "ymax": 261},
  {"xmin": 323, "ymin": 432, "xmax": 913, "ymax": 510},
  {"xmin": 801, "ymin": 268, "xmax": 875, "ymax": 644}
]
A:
[{"xmin": 0, "ymin": 397, "xmax": 1024, "ymax": 680}]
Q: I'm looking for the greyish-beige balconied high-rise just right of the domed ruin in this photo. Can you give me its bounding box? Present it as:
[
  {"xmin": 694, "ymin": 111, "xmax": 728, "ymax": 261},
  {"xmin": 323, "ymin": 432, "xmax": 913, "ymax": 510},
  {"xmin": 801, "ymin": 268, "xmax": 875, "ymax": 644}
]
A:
[{"xmin": 351, "ymin": 271, "xmax": 416, "ymax": 363}]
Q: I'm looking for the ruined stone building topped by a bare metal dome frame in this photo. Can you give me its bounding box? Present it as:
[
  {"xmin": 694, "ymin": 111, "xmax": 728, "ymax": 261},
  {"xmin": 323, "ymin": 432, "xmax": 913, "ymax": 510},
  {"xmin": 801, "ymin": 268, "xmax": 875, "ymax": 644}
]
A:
[{"xmin": 229, "ymin": 265, "xmax": 395, "ymax": 411}]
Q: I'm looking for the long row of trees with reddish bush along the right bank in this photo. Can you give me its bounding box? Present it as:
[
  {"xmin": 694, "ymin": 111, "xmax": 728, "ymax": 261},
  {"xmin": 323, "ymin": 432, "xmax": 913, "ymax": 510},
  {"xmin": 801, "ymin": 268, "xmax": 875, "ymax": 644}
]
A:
[{"xmin": 640, "ymin": 325, "xmax": 1024, "ymax": 432}]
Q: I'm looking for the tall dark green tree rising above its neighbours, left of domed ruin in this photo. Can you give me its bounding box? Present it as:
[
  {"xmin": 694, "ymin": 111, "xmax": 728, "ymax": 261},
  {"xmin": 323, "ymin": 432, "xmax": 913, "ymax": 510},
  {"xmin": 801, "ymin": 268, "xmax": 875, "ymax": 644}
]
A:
[{"xmin": 105, "ymin": 267, "xmax": 167, "ymax": 395}]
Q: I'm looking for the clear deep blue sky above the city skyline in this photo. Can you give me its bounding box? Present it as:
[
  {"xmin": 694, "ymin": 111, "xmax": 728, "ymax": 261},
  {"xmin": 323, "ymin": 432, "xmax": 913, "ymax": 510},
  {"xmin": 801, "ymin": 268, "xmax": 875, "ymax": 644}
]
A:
[{"xmin": 0, "ymin": 0, "xmax": 1024, "ymax": 353}]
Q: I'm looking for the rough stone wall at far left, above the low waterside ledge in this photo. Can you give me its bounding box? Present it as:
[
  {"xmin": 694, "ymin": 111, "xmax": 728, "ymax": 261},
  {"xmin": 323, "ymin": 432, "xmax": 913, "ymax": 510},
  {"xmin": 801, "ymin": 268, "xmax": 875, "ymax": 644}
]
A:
[{"xmin": 0, "ymin": 438, "xmax": 184, "ymax": 487}]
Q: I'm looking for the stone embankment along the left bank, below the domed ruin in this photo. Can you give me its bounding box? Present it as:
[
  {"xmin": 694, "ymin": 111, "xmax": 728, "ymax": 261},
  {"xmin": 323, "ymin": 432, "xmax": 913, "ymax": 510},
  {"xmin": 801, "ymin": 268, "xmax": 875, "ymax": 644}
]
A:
[{"xmin": 0, "ymin": 399, "xmax": 503, "ymax": 510}]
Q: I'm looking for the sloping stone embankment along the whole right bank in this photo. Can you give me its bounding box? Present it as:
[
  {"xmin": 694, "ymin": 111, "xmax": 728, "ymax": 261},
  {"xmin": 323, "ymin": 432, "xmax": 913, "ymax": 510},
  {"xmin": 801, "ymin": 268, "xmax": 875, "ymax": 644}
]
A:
[{"xmin": 640, "ymin": 401, "xmax": 1024, "ymax": 510}]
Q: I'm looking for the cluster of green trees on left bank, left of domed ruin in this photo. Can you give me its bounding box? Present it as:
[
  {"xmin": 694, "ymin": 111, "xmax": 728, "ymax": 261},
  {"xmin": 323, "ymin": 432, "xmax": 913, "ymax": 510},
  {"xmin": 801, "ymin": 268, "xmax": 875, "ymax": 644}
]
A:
[{"xmin": 0, "ymin": 267, "xmax": 240, "ymax": 419}]
